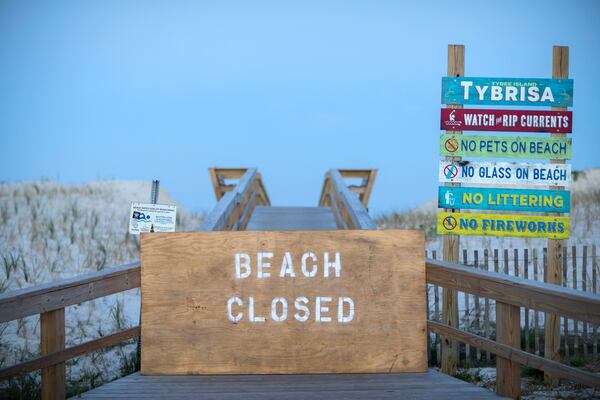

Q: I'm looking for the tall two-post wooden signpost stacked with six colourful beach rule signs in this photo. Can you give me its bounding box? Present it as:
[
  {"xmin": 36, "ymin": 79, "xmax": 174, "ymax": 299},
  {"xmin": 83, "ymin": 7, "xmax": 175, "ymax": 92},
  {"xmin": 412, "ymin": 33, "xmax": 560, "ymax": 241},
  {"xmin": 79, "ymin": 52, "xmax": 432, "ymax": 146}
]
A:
[{"xmin": 437, "ymin": 46, "xmax": 573, "ymax": 398}]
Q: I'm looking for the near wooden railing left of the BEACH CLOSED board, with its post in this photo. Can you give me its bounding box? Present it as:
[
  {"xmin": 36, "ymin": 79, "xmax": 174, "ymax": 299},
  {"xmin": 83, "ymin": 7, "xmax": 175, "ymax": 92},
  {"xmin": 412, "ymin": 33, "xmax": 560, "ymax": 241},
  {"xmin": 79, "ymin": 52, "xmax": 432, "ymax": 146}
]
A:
[{"xmin": 0, "ymin": 262, "xmax": 140, "ymax": 399}]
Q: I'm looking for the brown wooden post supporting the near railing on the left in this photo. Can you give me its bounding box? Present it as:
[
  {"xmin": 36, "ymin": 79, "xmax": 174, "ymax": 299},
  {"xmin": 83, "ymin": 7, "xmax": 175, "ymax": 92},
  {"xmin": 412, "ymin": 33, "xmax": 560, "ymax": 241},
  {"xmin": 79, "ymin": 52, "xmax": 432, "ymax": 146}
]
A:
[{"xmin": 40, "ymin": 308, "xmax": 65, "ymax": 400}]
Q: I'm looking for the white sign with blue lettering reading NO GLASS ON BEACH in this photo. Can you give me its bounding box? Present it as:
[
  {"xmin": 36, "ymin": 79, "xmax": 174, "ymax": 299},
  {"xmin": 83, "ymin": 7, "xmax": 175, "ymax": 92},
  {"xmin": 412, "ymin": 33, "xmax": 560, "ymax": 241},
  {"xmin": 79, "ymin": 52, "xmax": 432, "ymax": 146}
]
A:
[{"xmin": 438, "ymin": 160, "xmax": 571, "ymax": 186}]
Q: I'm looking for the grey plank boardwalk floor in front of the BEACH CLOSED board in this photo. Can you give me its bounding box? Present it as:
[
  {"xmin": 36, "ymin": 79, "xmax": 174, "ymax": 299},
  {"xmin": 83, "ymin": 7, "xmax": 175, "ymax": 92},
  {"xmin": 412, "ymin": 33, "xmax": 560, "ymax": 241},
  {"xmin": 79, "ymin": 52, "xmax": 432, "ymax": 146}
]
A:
[{"xmin": 72, "ymin": 370, "xmax": 498, "ymax": 400}]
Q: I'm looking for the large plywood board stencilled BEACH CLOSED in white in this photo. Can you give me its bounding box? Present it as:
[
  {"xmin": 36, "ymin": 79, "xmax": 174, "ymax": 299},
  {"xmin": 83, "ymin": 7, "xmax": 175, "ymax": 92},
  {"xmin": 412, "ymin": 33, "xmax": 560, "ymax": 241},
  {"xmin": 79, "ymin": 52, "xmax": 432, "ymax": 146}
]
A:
[{"xmin": 141, "ymin": 230, "xmax": 427, "ymax": 375}]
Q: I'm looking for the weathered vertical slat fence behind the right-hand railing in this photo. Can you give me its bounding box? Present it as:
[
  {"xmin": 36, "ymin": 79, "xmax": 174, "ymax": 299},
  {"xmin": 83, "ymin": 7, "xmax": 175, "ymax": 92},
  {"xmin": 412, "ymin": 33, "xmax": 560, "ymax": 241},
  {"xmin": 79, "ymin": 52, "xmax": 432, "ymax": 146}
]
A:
[{"xmin": 425, "ymin": 244, "xmax": 600, "ymax": 365}]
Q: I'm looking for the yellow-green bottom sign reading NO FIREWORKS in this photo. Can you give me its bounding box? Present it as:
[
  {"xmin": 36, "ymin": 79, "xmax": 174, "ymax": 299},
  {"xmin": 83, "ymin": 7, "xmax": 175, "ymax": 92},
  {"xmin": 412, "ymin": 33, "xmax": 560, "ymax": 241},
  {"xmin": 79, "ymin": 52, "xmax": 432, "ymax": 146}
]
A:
[{"xmin": 437, "ymin": 212, "xmax": 569, "ymax": 239}]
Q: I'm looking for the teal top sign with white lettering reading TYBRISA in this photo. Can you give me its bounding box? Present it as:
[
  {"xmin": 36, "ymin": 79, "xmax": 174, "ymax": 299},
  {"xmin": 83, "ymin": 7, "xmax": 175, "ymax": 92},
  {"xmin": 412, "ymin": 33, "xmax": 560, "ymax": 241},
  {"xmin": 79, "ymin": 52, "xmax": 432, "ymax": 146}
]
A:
[{"xmin": 442, "ymin": 77, "xmax": 573, "ymax": 107}]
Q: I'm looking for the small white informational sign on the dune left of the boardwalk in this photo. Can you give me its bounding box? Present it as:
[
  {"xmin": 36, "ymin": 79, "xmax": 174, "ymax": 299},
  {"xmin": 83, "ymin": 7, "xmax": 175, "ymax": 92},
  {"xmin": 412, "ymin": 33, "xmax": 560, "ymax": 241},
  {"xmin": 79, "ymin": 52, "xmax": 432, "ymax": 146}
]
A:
[{"xmin": 129, "ymin": 203, "xmax": 177, "ymax": 235}]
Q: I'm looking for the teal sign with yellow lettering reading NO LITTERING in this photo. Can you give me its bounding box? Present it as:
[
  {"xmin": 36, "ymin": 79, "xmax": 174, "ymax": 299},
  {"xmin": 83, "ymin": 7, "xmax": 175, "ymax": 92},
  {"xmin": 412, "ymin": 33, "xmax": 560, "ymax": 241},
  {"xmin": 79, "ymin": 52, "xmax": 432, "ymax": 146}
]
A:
[{"xmin": 438, "ymin": 186, "xmax": 571, "ymax": 213}]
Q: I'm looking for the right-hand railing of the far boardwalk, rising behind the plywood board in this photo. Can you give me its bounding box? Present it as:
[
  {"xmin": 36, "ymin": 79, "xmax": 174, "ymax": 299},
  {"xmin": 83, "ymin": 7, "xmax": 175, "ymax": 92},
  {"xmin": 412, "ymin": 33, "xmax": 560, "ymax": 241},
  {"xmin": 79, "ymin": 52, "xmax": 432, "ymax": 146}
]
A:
[{"xmin": 319, "ymin": 169, "xmax": 377, "ymax": 229}]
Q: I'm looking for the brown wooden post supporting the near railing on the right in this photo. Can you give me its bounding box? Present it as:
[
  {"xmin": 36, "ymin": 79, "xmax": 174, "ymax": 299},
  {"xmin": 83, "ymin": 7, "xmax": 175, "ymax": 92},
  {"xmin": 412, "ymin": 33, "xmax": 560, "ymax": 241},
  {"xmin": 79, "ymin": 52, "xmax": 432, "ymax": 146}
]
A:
[{"xmin": 496, "ymin": 302, "xmax": 521, "ymax": 399}]
